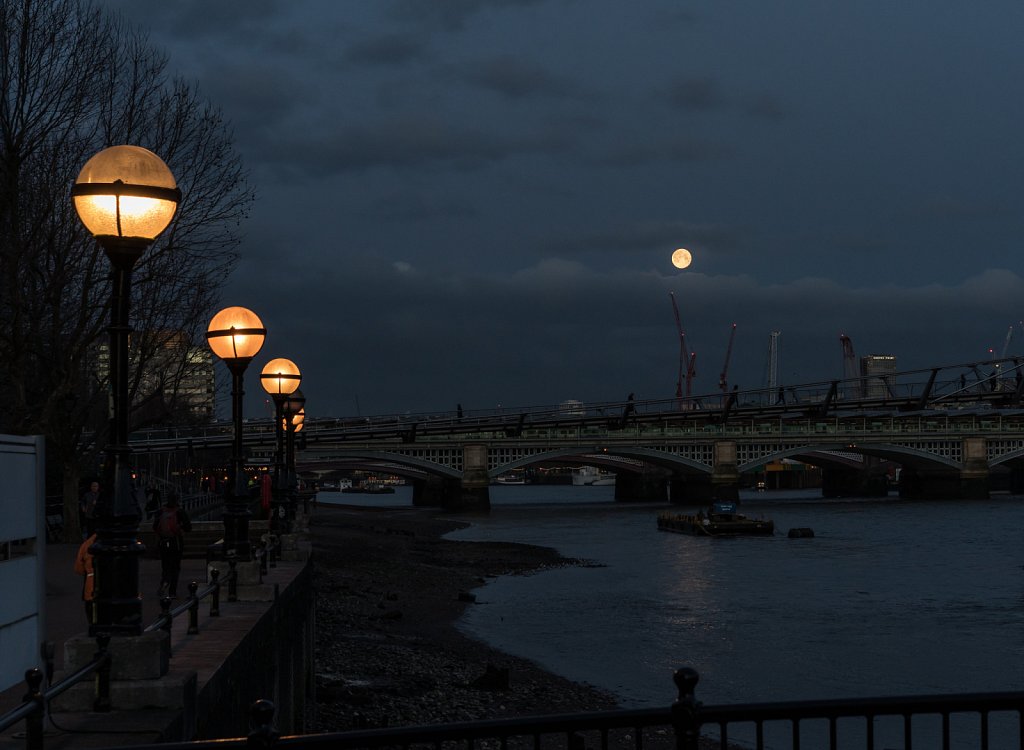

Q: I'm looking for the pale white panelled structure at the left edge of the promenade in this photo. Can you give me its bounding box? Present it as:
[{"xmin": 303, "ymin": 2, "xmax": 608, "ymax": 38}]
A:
[{"xmin": 0, "ymin": 434, "xmax": 46, "ymax": 691}]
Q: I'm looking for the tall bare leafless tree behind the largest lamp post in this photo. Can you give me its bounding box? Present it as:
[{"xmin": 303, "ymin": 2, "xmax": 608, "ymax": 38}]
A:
[{"xmin": 0, "ymin": 0, "xmax": 253, "ymax": 540}]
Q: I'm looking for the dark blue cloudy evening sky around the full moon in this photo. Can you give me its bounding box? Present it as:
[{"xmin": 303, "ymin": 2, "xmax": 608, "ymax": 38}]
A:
[{"xmin": 104, "ymin": 0, "xmax": 1024, "ymax": 416}]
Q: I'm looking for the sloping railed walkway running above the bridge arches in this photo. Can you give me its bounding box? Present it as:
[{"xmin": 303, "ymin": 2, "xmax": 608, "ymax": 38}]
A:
[{"xmin": 121, "ymin": 359, "xmax": 1024, "ymax": 450}]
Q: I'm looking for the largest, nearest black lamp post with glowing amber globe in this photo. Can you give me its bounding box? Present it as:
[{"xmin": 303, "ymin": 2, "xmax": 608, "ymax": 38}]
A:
[{"xmin": 71, "ymin": 145, "xmax": 181, "ymax": 635}]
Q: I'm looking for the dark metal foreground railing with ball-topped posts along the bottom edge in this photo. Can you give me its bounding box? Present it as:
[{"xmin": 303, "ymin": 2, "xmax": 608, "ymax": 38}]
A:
[{"xmin": 24, "ymin": 668, "xmax": 1024, "ymax": 750}]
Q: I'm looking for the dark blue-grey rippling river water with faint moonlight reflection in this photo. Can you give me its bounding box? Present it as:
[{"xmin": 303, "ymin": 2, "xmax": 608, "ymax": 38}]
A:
[{"xmin": 321, "ymin": 486, "xmax": 1024, "ymax": 745}]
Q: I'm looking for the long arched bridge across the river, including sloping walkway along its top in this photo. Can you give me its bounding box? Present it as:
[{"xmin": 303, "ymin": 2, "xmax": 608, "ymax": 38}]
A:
[{"xmin": 132, "ymin": 360, "xmax": 1024, "ymax": 509}]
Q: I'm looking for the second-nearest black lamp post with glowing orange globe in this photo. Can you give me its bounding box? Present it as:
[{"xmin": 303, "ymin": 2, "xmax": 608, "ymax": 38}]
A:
[{"xmin": 206, "ymin": 307, "xmax": 266, "ymax": 561}]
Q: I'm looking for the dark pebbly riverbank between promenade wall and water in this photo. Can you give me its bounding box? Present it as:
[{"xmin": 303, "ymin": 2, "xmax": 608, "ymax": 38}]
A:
[{"xmin": 310, "ymin": 505, "xmax": 616, "ymax": 732}]
